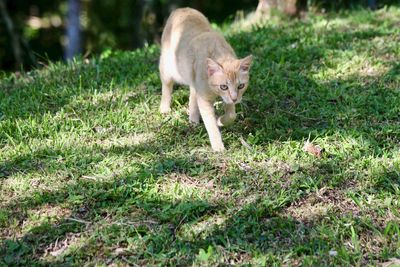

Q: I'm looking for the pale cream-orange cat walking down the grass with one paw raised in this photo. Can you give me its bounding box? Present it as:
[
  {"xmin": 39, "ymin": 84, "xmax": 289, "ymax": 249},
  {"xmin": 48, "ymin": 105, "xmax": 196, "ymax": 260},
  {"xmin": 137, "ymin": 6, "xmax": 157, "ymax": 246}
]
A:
[{"xmin": 160, "ymin": 8, "xmax": 252, "ymax": 151}]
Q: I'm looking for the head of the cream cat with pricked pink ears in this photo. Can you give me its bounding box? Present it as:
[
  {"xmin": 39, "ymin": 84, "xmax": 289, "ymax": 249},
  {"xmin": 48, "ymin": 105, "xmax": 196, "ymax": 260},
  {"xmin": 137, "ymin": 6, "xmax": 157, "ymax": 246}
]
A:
[{"xmin": 207, "ymin": 56, "xmax": 253, "ymax": 104}]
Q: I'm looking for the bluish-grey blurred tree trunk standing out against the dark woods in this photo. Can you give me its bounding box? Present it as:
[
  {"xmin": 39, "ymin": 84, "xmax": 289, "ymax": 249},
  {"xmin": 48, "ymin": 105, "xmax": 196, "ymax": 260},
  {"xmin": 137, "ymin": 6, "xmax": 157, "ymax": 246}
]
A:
[{"xmin": 65, "ymin": 0, "xmax": 81, "ymax": 60}]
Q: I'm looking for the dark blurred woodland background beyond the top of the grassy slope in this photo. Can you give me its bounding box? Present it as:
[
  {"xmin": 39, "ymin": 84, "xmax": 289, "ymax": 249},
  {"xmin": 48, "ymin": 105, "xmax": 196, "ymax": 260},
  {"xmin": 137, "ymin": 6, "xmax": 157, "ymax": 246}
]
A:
[{"xmin": 0, "ymin": 0, "xmax": 399, "ymax": 71}]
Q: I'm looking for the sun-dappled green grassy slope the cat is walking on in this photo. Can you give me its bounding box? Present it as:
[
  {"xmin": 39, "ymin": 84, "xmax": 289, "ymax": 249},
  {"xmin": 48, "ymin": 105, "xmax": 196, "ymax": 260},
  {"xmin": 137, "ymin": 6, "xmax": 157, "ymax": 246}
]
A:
[{"xmin": 0, "ymin": 8, "xmax": 400, "ymax": 266}]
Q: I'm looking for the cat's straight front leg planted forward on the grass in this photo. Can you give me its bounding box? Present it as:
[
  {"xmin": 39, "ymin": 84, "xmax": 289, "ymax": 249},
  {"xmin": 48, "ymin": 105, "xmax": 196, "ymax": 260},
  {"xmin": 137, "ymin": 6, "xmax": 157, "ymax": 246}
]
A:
[{"xmin": 197, "ymin": 95, "xmax": 225, "ymax": 151}]
